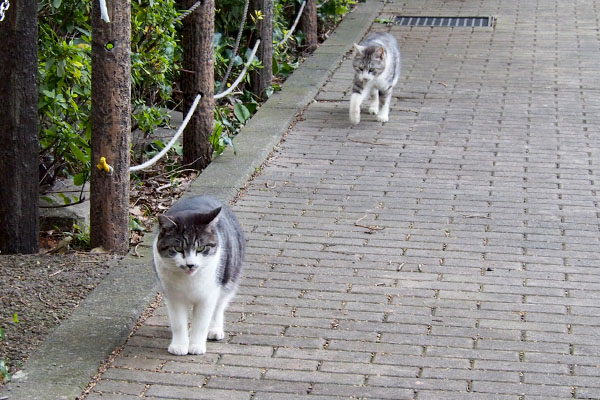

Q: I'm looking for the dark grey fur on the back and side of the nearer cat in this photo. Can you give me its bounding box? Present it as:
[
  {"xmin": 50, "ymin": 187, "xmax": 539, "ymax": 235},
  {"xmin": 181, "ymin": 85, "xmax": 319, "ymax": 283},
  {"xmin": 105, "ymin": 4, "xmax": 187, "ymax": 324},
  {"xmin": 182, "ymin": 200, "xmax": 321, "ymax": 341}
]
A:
[{"xmin": 165, "ymin": 195, "xmax": 245, "ymax": 288}]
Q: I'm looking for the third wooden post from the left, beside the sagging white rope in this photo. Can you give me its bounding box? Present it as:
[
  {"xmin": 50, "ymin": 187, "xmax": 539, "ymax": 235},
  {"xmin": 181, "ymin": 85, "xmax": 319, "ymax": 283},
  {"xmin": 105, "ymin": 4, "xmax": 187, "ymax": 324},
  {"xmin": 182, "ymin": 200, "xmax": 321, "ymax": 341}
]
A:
[{"xmin": 181, "ymin": 0, "xmax": 215, "ymax": 170}]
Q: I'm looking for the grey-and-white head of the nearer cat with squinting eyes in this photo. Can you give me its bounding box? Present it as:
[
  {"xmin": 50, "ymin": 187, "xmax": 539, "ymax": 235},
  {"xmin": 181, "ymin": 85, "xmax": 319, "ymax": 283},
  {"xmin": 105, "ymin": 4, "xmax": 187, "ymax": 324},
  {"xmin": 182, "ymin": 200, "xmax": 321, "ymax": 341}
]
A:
[{"xmin": 156, "ymin": 209, "xmax": 220, "ymax": 275}]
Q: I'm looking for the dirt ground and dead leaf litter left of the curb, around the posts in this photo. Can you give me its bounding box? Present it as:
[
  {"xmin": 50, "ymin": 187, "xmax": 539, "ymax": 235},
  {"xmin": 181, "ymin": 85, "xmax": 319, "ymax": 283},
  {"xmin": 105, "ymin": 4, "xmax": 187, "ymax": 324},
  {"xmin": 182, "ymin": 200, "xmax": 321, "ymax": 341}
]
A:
[{"xmin": 0, "ymin": 169, "xmax": 197, "ymax": 386}]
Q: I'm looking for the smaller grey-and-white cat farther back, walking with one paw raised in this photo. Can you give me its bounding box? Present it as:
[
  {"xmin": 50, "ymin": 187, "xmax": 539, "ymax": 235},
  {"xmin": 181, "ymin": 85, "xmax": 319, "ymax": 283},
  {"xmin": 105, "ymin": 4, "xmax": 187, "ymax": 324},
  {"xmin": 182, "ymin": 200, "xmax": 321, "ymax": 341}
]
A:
[{"xmin": 350, "ymin": 32, "xmax": 401, "ymax": 125}]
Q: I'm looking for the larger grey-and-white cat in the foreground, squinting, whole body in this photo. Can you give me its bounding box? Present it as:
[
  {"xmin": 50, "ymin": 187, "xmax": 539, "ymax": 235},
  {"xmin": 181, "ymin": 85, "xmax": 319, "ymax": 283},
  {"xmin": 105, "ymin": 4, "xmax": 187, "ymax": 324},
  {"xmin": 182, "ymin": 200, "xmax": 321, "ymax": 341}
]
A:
[{"xmin": 153, "ymin": 196, "xmax": 244, "ymax": 355}]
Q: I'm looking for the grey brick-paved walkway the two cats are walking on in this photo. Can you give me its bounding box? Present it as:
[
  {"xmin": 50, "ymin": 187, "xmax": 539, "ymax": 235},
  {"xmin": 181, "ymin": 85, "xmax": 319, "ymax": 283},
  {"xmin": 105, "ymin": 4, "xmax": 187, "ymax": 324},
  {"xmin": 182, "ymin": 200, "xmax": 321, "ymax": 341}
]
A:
[{"xmin": 87, "ymin": 0, "xmax": 600, "ymax": 400}]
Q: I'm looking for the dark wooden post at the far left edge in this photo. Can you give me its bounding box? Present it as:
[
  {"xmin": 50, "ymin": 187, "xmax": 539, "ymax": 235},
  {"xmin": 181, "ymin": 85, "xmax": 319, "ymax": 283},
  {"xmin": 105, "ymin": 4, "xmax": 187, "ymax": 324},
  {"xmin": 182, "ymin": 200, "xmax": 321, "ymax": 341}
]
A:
[{"xmin": 0, "ymin": 0, "xmax": 39, "ymax": 254}]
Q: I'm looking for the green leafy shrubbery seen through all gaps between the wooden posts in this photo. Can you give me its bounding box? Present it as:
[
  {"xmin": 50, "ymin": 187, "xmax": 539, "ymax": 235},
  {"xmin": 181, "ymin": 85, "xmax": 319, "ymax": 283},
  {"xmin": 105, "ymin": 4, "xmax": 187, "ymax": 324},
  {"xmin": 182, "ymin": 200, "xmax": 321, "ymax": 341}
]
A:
[{"xmin": 38, "ymin": 0, "xmax": 356, "ymax": 184}]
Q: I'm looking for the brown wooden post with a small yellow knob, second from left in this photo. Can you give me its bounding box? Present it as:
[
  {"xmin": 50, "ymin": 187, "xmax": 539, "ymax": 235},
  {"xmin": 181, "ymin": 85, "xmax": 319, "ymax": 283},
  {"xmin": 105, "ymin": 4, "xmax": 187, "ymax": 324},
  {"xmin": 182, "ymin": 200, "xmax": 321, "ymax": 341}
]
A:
[{"xmin": 90, "ymin": 0, "xmax": 131, "ymax": 254}]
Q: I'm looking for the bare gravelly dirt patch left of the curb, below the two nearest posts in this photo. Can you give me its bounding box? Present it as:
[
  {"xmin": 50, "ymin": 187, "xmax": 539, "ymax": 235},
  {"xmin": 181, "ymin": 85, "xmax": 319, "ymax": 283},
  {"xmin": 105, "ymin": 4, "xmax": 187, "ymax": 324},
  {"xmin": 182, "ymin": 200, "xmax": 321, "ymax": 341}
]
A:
[{"xmin": 0, "ymin": 252, "xmax": 118, "ymax": 385}]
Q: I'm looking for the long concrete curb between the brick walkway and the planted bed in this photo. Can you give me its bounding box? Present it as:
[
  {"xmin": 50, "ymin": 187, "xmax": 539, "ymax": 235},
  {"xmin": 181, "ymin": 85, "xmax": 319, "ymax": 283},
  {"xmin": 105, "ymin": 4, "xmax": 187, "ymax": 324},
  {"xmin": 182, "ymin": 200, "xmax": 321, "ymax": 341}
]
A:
[{"xmin": 0, "ymin": 0, "xmax": 384, "ymax": 400}]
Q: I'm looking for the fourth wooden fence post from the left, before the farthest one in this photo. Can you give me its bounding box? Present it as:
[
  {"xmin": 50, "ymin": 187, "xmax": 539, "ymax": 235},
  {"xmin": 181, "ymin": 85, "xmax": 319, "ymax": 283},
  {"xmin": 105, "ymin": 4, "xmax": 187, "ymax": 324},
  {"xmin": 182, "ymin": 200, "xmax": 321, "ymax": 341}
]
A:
[{"xmin": 250, "ymin": 0, "xmax": 273, "ymax": 98}]
